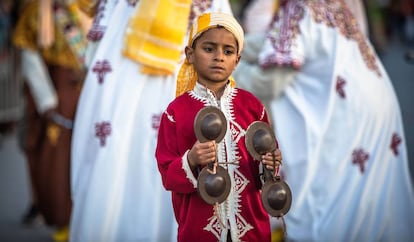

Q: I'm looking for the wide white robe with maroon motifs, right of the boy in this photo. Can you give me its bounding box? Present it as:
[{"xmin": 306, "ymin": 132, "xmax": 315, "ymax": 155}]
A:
[{"xmin": 235, "ymin": 0, "xmax": 414, "ymax": 242}]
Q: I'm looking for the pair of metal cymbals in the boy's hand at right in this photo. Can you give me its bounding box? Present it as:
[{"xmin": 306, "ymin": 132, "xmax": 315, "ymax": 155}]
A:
[{"xmin": 245, "ymin": 121, "xmax": 292, "ymax": 217}]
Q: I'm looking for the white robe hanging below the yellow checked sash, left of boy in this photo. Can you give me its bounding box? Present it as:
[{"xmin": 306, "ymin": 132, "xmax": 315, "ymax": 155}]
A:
[{"xmin": 70, "ymin": 0, "xmax": 231, "ymax": 242}]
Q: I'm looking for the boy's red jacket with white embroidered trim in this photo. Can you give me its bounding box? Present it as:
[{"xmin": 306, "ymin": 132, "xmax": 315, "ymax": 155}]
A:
[{"xmin": 156, "ymin": 84, "xmax": 271, "ymax": 242}]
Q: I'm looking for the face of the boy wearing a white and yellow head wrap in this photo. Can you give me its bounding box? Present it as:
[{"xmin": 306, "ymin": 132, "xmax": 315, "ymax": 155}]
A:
[{"xmin": 185, "ymin": 28, "xmax": 240, "ymax": 89}]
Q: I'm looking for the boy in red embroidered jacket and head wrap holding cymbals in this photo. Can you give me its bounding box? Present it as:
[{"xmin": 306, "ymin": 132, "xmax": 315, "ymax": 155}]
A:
[{"xmin": 156, "ymin": 13, "xmax": 281, "ymax": 242}]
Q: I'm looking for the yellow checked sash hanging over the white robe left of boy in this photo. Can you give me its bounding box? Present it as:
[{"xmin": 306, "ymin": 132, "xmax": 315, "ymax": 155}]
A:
[{"xmin": 123, "ymin": 0, "xmax": 192, "ymax": 75}]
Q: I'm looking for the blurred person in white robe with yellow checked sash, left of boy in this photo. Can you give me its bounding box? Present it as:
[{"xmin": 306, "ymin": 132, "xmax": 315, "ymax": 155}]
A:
[{"xmin": 70, "ymin": 0, "xmax": 231, "ymax": 242}]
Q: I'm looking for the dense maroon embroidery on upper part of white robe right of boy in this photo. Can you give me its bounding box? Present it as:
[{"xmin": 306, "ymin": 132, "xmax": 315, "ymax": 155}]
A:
[{"xmin": 262, "ymin": 0, "xmax": 381, "ymax": 76}]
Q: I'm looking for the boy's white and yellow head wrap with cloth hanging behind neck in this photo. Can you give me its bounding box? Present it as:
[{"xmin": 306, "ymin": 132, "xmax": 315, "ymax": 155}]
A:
[{"xmin": 175, "ymin": 12, "xmax": 244, "ymax": 96}]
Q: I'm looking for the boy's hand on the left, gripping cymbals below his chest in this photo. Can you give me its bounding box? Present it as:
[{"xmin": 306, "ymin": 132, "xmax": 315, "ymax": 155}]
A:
[{"xmin": 187, "ymin": 140, "xmax": 217, "ymax": 169}]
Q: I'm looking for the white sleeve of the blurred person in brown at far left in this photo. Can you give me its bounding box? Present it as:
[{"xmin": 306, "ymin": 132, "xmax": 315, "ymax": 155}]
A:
[{"xmin": 22, "ymin": 49, "xmax": 58, "ymax": 113}]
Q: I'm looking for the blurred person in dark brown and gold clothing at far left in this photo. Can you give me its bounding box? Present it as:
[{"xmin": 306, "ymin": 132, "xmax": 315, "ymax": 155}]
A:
[{"xmin": 13, "ymin": 0, "xmax": 89, "ymax": 241}]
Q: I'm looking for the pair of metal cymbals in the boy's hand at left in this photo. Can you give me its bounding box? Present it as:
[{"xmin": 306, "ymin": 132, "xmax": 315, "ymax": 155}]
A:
[{"xmin": 194, "ymin": 106, "xmax": 231, "ymax": 204}]
